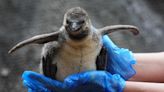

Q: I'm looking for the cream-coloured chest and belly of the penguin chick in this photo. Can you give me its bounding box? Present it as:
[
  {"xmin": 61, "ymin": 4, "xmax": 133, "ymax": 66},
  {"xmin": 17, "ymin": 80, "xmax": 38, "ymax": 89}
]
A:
[{"xmin": 56, "ymin": 36, "xmax": 101, "ymax": 81}]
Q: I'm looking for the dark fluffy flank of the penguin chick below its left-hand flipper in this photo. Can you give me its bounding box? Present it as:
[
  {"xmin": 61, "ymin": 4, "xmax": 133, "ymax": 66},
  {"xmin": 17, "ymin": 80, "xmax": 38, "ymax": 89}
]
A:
[{"xmin": 41, "ymin": 42, "xmax": 58, "ymax": 79}]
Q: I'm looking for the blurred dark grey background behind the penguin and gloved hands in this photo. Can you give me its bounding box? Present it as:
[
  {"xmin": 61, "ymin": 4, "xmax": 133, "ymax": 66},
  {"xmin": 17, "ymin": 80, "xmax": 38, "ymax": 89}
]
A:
[{"xmin": 0, "ymin": 0, "xmax": 164, "ymax": 92}]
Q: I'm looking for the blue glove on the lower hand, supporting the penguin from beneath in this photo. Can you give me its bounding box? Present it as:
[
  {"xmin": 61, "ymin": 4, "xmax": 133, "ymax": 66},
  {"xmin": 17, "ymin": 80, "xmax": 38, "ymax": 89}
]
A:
[{"xmin": 22, "ymin": 71, "xmax": 125, "ymax": 92}]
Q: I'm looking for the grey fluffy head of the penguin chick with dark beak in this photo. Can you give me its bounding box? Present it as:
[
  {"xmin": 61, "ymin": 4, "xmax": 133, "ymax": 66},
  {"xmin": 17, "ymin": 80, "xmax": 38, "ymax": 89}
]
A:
[{"xmin": 64, "ymin": 7, "xmax": 91, "ymax": 40}]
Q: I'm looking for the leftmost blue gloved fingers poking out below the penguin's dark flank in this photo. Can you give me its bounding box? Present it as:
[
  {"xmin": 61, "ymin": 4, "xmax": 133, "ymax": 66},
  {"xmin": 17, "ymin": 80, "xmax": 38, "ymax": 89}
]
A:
[{"xmin": 22, "ymin": 71, "xmax": 63, "ymax": 92}]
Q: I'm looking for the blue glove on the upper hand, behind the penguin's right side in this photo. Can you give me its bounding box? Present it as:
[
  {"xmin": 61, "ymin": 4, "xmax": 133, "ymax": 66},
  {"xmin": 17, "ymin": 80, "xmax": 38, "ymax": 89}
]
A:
[{"xmin": 103, "ymin": 35, "xmax": 136, "ymax": 80}]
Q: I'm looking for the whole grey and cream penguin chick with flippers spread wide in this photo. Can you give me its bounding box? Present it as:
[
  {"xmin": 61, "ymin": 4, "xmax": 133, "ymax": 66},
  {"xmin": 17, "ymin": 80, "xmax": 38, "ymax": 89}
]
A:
[{"xmin": 9, "ymin": 7, "xmax": 139, "ymax": 81}]
